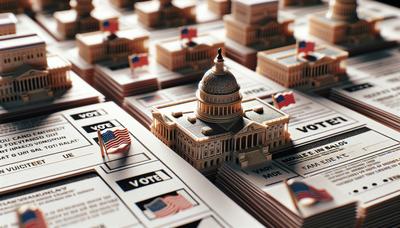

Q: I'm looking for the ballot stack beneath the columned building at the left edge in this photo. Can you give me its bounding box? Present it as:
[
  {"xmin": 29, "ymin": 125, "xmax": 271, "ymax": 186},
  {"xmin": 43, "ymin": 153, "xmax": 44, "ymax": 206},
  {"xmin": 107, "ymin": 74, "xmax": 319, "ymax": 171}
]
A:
[{"xmin": 0, "ymin": 72, "xmax": 104, "ymax": 123}]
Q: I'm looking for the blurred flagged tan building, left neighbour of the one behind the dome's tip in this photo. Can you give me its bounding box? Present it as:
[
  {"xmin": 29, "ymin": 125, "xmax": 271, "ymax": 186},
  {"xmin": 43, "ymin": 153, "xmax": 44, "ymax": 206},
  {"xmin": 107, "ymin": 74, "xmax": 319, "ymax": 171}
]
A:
[{"xmin": 76, "ymin": 29, "xmax": 149, "ymax": 64}]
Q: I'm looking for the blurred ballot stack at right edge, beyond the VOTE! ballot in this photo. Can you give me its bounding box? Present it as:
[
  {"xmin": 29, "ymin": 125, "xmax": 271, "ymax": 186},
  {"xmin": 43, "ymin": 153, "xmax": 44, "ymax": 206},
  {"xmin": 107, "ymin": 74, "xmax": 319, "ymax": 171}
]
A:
[{"xmin": 331, "ymin": 73, "xmax": 400, "ymax": 130}]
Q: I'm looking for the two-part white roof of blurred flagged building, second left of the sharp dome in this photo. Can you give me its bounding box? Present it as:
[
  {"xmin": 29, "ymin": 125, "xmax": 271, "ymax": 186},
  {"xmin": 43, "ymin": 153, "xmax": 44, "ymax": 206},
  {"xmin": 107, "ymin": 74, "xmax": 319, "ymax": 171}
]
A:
[{"xmin": 76, "ymin": 29, "xmax": 149, "ymax": 46}]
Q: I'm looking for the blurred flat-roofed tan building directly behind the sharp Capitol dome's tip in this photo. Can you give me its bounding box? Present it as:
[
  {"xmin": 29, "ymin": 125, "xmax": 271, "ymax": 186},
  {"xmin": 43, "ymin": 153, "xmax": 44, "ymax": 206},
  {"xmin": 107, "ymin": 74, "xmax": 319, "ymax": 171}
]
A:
[{"xmin": 156, "ymin": 35, "xmax": 224, "ymax": 71}]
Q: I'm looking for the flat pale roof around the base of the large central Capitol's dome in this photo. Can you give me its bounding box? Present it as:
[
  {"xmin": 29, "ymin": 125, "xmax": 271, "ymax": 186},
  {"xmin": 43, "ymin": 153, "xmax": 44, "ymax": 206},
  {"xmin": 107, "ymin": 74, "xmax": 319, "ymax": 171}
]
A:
[{"xmin": 156, "ymin": 98, "xmax": 289, "ymax": 139}]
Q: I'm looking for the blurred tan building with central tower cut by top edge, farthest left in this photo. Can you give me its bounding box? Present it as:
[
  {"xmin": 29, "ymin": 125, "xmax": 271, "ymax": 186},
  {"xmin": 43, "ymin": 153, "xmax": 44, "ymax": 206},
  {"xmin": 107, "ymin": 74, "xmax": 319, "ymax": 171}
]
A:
[{"xmin": 54, "ymin": 0, "xmax": 118, "ymax": 39}]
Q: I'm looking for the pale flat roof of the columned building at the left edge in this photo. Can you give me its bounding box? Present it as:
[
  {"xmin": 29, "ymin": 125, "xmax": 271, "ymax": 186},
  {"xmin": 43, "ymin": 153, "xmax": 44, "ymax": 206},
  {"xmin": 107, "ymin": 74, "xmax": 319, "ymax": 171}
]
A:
[{"xmin": 0, "ymin": 34, "xmax": 45, "ymax": 51}]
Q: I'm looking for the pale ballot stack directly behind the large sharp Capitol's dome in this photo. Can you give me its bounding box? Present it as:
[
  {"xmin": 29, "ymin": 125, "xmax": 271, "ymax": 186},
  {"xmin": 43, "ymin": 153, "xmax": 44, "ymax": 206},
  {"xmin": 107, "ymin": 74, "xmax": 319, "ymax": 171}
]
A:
[{"xmin": 123, "ymin": 58, "xmax": 283, "ymax": 127}]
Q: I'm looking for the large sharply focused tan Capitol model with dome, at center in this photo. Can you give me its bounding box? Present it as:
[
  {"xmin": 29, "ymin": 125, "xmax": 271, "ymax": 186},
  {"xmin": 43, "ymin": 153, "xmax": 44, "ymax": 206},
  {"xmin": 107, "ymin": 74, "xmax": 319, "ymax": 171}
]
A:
[{"xmin": 151, "ymin": 51, "xmax": 290, "ymax": 174}]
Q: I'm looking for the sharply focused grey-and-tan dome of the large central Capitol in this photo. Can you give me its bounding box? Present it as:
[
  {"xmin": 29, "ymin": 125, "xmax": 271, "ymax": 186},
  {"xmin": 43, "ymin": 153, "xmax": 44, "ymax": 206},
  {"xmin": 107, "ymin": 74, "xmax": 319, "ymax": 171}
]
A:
[{"xmin": 196, "ymin": 49, "xmax": 243, "ymax": 123}]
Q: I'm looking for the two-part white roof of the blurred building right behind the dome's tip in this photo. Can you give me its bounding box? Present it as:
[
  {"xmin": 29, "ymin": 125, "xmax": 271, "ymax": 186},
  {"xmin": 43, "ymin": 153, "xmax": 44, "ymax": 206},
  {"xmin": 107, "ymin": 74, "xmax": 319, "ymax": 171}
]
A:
[{"xmin": 157, "ymin": 35, "xmax": 222, "ymax": 52}]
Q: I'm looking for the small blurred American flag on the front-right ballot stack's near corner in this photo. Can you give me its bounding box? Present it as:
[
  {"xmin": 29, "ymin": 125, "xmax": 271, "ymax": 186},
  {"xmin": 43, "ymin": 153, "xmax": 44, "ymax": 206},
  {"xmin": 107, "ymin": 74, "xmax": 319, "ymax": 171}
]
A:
[{"xmin": 288, "ymin": 181, "xmax": 333, "ymax": 205}]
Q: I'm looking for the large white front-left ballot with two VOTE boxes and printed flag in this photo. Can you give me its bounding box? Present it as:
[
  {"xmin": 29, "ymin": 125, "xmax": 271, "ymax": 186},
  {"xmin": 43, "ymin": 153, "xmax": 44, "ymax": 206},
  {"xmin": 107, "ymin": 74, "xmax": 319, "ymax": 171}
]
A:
[{"xmin": 0, "ymin": 102, "xmax": 261, "ymax": 227}]
